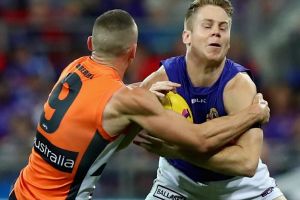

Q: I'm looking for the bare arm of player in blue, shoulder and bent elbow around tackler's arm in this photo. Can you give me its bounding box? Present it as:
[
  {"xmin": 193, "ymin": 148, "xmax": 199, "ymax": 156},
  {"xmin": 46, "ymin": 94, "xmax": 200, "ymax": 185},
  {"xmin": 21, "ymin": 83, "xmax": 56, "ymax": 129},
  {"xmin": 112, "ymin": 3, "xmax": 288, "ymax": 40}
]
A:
[{"xmin": 169, "ymin": 74, "xmax": 263, "ymax": 176}]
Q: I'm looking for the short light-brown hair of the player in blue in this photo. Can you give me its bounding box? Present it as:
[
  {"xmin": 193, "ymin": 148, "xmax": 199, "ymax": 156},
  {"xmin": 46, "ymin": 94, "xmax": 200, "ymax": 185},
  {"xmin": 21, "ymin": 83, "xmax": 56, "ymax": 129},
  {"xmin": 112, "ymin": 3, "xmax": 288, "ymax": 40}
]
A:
[{"xmin": 184, "ymin": 0, "xmax": 234, "ymax": 29}]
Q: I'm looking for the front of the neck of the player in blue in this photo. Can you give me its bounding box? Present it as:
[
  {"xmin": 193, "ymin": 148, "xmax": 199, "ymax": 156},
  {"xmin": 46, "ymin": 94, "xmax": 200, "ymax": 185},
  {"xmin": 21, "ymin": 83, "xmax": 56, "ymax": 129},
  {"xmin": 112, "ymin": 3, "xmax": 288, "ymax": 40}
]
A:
[{"xmin": 186, "ymin": 54, "xmax": 226, "ymax": 87}]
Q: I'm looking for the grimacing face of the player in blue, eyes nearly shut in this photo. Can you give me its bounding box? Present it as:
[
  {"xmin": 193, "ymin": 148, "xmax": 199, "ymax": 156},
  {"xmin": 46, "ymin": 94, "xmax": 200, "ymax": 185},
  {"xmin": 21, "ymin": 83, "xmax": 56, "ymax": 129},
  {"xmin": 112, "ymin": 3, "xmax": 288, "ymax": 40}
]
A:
[{"xmin": 188, "ymin": 5, "xmax": 231, "ymax": 61}]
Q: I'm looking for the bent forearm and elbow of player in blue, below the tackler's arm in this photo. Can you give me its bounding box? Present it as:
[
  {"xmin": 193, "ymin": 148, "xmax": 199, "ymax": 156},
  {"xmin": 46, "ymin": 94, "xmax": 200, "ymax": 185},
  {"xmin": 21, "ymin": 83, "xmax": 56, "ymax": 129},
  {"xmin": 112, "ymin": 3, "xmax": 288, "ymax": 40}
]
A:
[{"xmin": 173, "ymin": 128, "xmax": 263, "ymax": 176}]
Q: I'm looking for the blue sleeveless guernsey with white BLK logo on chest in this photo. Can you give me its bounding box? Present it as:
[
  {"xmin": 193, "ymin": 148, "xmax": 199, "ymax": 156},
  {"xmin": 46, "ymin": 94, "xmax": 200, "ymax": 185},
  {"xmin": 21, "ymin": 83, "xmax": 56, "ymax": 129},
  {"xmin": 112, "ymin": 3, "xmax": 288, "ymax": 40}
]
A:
[{"xmin": 161, "ymin": 56, "xmax": 251, "ymax": 182}]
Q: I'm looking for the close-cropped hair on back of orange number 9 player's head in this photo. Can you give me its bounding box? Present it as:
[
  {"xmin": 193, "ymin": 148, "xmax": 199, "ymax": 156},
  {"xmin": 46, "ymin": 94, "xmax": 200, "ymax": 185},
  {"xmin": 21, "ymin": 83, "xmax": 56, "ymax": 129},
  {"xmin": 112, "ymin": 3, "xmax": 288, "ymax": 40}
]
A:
[{"xmin": 92, "ymin": 9, "xmax": 137, "ymax": 56}]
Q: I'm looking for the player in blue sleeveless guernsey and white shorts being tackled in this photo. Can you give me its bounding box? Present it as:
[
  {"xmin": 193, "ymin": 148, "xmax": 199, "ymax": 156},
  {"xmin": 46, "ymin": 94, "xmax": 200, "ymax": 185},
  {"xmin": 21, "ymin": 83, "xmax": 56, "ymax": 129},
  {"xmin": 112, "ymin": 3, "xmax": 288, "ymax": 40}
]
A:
[{"xmin": 136, "ymin": 0, "xmax": 286, "ymax": 200}]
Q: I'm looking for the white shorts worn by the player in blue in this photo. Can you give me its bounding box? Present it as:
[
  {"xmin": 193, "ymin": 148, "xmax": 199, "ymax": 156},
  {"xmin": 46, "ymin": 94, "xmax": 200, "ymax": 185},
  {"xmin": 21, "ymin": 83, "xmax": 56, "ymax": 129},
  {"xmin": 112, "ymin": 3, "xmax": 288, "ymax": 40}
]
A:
[{"xmin": 146, "ymin": 158, "xmax": 283, "ymax": 200}]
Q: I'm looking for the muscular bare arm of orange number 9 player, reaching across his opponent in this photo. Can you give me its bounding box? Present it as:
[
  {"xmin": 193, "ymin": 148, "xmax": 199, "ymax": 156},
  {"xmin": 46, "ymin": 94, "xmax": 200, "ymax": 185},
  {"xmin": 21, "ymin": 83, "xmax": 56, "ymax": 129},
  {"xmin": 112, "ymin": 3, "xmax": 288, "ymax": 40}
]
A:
[{"xmin": 105, "ymin": 82, "xmax": 267, "ymax": 153}]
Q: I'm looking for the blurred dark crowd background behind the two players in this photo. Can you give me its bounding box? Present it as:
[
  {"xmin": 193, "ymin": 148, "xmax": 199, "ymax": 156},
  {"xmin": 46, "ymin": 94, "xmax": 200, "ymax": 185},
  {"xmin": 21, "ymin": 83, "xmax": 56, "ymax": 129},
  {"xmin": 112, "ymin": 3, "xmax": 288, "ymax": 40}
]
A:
[{"xmin": 0, "ymin": 0, "xmax": 300, "ymax": 200}]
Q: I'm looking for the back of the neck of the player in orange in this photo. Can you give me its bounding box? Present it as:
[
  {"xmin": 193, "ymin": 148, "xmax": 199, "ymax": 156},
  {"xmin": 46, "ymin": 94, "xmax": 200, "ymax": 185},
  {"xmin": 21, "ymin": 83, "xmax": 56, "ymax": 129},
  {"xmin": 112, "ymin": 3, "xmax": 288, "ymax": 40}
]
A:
[{"xmin": 91, "ymin": 52, "xmax": 126, "ymax": 79}]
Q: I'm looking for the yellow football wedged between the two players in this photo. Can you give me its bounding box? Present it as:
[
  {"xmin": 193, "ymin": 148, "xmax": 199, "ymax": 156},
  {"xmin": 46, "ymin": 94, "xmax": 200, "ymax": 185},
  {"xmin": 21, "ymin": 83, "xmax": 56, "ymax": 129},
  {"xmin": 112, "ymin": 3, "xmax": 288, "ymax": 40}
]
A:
[{"xmin": 162, "ymin": 91, "xmax": 193, "ymax": 122}]
